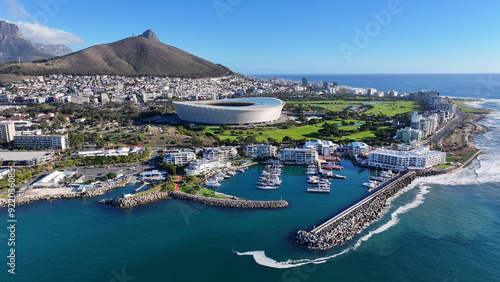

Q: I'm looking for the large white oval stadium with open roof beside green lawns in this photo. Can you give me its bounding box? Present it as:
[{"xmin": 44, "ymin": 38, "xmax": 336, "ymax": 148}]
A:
[{"xmin": 174, "ymin": 97, "xmax": 285, "ymax": 125}]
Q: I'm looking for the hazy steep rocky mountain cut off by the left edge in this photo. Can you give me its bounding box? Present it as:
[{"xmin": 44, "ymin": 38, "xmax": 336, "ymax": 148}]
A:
[{"xmin": 0, "ymin": 20, "xmax": 53, "ymax": 62}]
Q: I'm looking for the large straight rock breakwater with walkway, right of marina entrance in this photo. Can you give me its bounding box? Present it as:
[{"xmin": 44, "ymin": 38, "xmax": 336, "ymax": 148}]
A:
[{"xmin": 296, "ymin": 171, "xmax": 417, "ymax": 250}]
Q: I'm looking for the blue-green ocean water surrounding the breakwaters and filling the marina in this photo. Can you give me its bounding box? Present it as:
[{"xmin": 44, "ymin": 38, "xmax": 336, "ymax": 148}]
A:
[{"xmin": 0, "ymin": 74, "xmax": 500, "ymax": 281}]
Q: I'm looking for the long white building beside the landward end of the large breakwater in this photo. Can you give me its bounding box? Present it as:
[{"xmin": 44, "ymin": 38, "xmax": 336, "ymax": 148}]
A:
[{"xmin": 368, "ymin": 147, "xmax": 446, "ymax": 170}]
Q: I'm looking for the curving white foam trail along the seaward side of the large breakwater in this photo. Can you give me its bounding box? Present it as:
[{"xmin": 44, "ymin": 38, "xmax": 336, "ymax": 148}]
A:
[{"xmin": 233, "ymin": 184, "xmax": 430, "ymax": 269}]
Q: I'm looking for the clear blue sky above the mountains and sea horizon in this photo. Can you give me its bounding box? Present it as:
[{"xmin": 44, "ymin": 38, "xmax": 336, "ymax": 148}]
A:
[{"xmin": 0, "ymin": 0, "xmax": 500, "ymax": 74}]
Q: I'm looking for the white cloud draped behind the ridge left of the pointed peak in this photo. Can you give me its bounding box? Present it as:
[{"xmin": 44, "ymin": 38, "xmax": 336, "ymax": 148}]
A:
[{"xmin": 16, "ymin": 22, "xmax": 83, "ymax": 45}]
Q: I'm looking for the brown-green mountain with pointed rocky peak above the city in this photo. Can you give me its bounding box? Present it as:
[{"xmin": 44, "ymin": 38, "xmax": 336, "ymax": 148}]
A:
[{"xmin": 1, "ymin": 30, "xmax": 232, "ymax": 78}]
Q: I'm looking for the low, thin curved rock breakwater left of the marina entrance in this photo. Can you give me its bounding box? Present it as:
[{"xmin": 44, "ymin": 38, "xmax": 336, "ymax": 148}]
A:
[{"xmin": 99, "ymin": 191, "xmax": 288, "ymax": 209}]
